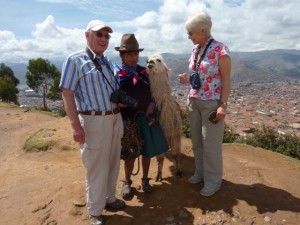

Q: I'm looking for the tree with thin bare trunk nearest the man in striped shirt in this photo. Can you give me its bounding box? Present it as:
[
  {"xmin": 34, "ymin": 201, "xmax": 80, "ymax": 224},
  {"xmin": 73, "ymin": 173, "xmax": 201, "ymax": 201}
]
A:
[{"xmin": 26, "ymin": 58, "xmax": 60, "ymax": 110}]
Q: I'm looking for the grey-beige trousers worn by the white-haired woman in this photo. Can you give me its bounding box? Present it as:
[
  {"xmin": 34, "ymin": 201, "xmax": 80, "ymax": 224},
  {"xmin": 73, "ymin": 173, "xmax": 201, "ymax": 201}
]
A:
[{"xmin": 187, "ymin": 98, "xmax": 224, "ymax": 190}]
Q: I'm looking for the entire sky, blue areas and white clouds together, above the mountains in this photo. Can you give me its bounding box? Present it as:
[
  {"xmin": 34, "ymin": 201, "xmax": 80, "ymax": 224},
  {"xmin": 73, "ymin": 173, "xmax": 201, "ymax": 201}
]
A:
[{"xmin": 0, "ymin": 0, "xmax": 300, "ymax": 63}]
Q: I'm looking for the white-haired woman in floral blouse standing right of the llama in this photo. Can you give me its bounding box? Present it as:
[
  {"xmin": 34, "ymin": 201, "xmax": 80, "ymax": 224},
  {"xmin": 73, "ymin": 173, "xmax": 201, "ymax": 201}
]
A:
[{"xmin": 178, "ymin": 12, "xmax": 231, "ymax": 196}]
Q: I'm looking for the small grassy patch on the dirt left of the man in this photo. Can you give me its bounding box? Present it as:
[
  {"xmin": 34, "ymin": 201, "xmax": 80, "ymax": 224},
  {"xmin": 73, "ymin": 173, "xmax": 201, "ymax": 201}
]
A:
[{"xmin": 23, "ymin": 128, "xmax": 49, "ymax": 152}]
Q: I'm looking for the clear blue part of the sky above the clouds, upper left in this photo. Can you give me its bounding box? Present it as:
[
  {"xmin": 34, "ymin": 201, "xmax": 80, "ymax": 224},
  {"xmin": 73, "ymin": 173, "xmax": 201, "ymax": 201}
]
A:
[{"xmin": 0, "ymin": 0, "xmax": 163, "ymax": 38}]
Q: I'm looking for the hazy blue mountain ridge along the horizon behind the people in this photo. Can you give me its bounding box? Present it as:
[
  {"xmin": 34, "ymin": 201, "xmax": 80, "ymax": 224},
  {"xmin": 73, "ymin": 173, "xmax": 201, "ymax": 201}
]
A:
[{"xmin": 4, "ymin": 49, "xmax": 300, "ymax": 85}]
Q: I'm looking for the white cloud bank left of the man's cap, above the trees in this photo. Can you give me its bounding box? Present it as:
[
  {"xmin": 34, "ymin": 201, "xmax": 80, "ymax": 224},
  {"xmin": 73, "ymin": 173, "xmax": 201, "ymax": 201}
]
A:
[{"xmin": 0, "ymin": 15, "xmax": 85, "ymax": 62}]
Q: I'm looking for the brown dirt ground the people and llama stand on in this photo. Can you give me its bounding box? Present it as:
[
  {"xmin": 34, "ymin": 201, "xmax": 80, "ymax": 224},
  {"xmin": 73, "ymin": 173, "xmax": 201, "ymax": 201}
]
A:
[{"xmin": 0, "ymin": 103, "xmax": 300, "ymax": 225}]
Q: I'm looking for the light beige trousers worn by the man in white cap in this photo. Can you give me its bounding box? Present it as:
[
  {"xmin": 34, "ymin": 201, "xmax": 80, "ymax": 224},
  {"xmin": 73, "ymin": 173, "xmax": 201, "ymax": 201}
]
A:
[{"xmin": 79, "ymin": 113, "xmax": 123, "ymax": 216}]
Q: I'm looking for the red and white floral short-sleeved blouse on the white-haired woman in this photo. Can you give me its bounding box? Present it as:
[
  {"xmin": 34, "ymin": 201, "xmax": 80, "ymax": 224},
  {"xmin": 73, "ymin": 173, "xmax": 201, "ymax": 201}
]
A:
[{"xmin": 188, "ymin": 37, "xmax": 230, "ymax": 100}]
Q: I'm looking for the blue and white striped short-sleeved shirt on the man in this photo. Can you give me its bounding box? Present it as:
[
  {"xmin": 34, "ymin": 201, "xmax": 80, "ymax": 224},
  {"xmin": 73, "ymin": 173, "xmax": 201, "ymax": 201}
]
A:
[{"xmin": 59, "ymin": 50, "xmax": 119, "ymax": 111}]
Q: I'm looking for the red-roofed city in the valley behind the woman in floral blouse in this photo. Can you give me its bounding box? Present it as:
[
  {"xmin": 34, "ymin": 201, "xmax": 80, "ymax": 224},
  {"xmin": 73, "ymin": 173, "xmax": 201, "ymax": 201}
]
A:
[{"xmin": 175, "ymin": 81, "xmax": 300, "ymax": 136}]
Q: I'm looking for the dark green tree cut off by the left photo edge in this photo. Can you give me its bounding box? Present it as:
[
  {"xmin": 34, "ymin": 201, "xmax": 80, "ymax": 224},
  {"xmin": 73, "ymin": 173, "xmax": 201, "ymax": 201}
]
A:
[{"xmin": 0, "ymin": 63, "xmax": 20, "ymax": 104}]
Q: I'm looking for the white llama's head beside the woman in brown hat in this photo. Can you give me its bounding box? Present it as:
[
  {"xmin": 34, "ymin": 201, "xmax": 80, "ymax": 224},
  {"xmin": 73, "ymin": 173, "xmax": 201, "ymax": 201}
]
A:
[{"xmin": 146, "ymin": 55, "xmax": 170, "ymax": 77}]
